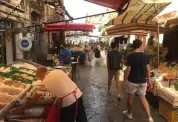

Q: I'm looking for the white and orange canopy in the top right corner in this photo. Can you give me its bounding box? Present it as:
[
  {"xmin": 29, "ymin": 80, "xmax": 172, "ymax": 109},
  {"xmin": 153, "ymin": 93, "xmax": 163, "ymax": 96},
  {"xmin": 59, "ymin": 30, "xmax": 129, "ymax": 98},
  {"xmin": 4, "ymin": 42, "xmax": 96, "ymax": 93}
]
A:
[{"xmin": 153, "ymin": 0, "xmax": 178, "ymax": 23}]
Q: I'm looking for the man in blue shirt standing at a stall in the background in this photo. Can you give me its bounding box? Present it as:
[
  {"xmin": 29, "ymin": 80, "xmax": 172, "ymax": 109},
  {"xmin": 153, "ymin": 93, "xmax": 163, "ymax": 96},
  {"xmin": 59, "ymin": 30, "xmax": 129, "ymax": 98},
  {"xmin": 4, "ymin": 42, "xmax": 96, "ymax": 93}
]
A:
[{"xmin": 60, "ymin": 44, "xmax": 72, "ymax": 66}]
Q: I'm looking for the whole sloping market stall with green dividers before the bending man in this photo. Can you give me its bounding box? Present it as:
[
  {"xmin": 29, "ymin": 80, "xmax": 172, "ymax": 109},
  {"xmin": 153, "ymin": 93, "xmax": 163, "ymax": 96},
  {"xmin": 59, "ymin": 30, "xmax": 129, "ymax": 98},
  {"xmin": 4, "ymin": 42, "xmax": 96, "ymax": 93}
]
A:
[{"xmin": 0, "ymin": 60, "xmax": 71, "ymax": 122}]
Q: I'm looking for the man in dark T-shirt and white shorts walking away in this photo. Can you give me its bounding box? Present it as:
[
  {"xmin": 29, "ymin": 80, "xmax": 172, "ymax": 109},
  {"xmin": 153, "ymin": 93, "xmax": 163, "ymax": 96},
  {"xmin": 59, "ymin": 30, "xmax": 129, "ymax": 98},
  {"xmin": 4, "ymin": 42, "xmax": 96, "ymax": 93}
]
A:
[{"xmin": 123, "ymin": 39, "xmax": 153, "ymax": 122}]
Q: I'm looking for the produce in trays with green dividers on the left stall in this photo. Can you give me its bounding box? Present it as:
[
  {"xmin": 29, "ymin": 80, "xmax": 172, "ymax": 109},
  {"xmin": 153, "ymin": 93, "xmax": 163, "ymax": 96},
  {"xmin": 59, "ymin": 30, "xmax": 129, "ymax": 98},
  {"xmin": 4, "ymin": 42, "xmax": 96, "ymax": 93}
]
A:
[{"xmin": 0, "ymin": 61, "xmax": 59, "ymax": 118}]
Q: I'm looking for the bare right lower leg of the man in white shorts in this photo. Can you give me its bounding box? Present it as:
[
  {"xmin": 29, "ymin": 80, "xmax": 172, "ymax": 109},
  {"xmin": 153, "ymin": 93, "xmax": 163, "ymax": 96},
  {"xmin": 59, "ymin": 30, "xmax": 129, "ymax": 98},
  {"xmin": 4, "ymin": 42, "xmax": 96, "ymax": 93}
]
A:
[{"xmin": 139, "ymin": 96, "xmax": 151, "ymax": 117}]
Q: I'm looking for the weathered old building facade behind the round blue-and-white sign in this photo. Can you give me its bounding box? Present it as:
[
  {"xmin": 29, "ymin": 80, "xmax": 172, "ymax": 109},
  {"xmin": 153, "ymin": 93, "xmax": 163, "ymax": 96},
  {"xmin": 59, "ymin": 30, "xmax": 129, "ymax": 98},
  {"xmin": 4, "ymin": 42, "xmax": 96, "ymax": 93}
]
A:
[{"xmin": 0, "ymin": 0, "xmax": 64, "ymax": 64}]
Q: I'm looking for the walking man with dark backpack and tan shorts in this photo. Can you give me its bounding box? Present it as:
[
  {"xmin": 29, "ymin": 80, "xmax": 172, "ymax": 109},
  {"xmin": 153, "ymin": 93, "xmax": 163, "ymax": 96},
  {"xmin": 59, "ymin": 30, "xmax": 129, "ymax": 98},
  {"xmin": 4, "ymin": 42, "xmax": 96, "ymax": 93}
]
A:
[{"xmin": 107, "ymin": 42, "xmax": 122, "ymax": 99}]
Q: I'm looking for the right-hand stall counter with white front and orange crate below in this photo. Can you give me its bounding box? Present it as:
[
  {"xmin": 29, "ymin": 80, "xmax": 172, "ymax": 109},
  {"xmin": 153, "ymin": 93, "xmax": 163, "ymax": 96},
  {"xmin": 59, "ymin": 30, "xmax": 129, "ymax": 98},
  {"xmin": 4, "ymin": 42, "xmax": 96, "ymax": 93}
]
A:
[{"xmin": 151, "ymin": 64, "xmax": 178, "ymax": 122}]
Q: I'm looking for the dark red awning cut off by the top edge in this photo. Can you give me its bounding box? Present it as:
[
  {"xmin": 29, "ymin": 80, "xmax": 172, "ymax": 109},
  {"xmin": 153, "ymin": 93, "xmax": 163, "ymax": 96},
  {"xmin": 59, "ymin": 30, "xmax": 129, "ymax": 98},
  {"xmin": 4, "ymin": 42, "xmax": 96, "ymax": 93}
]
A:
[{"xmin": 82, "ymin": 0, "xmax": 130, "ymax": 9}]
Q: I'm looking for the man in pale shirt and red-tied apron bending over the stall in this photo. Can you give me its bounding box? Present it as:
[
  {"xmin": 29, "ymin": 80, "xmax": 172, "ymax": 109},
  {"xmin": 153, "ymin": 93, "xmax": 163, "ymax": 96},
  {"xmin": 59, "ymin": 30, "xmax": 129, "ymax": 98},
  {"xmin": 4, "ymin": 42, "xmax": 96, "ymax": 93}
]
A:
[{"xmin": 36, "ymin": 67, "xmax": 87, "ymax": 122}]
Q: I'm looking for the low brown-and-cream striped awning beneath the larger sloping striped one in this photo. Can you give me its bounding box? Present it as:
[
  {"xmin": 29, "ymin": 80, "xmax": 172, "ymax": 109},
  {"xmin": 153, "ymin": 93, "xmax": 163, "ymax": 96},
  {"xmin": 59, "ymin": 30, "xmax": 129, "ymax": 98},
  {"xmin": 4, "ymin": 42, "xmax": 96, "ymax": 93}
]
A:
[{"xmin": 106, "ymin": 24, "xmax": 169, "ymax": 36}]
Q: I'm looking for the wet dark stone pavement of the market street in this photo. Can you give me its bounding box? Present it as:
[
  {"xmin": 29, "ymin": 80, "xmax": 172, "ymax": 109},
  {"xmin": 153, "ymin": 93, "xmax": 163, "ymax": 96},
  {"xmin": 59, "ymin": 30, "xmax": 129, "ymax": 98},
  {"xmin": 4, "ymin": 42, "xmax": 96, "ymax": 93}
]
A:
[{"xmin": 77, "ymin": 56, "xmax": 166, "ymax": 122}]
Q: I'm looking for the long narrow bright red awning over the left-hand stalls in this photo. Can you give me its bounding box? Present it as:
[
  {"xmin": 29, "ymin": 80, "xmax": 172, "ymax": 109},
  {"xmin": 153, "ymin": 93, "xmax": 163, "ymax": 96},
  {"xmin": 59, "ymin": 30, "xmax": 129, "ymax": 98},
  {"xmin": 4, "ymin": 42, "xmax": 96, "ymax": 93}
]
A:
[{"xmin": 44, "ymin": 23, "xmax": 95, "ymax": 31}]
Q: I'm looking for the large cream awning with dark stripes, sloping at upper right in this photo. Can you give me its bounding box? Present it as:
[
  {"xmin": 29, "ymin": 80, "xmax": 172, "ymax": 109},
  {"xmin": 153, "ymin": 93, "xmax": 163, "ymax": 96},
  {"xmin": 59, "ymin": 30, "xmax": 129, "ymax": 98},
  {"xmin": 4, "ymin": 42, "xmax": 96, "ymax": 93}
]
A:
[{"xmin": 107, "ymin": 0, "xmax": 170, "ymax": 25}]
